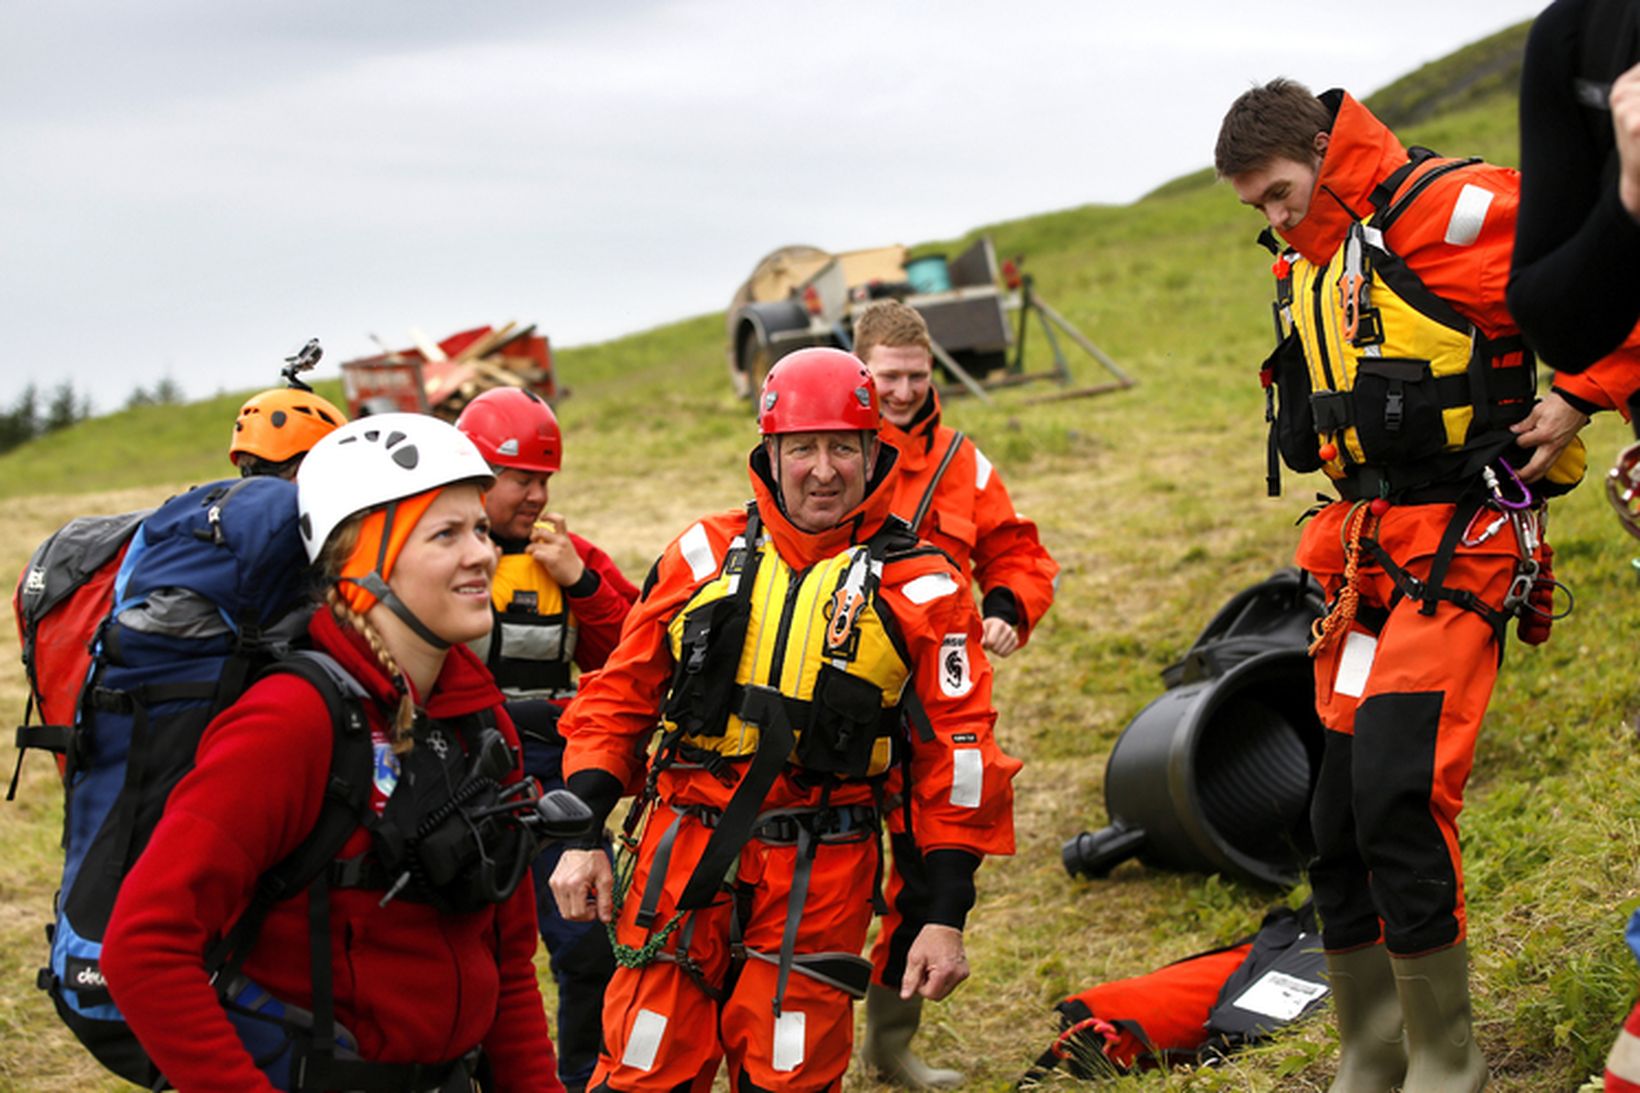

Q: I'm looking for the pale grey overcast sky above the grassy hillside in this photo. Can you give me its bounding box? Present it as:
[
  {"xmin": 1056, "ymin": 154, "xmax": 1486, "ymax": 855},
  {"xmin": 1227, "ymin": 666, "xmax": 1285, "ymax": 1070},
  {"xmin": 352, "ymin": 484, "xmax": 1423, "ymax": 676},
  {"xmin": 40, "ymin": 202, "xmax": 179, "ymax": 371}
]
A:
[{"xmin": 0, "ymin": 0, "xmax": 1543, "ymax": 410}]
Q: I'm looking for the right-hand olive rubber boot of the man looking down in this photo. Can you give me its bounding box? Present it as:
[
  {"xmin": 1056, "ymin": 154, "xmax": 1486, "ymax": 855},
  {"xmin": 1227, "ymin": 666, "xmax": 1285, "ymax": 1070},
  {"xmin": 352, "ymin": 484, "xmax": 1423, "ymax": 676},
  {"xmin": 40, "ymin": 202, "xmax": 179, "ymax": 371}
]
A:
[{"xmin": 1389, "ymin": 942, "xmax": 1486, "ymax": 1093}]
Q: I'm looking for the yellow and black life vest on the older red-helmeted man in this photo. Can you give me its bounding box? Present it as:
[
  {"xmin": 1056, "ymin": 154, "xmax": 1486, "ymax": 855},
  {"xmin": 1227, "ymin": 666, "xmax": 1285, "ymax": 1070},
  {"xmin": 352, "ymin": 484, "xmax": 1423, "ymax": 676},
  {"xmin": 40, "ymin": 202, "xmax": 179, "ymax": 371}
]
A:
[{"xmin": 663, "ymin": 512, "xmax": 910, "ymax": 776}]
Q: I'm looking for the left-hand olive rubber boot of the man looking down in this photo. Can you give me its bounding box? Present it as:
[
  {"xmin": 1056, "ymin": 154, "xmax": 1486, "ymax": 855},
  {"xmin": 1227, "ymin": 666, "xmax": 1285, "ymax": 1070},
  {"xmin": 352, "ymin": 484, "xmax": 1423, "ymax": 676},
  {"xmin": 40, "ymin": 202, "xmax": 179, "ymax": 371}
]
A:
[{"xmin": 1327, "ymin": 944, "xmax": 1407, "ymax": 1093}]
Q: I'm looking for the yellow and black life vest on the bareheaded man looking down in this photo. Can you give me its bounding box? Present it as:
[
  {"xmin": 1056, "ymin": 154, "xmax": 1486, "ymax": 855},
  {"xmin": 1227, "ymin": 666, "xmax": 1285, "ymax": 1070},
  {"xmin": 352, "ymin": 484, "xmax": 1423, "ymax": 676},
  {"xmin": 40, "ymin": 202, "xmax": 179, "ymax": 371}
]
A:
[{"xmin": 1266, "ymin": 149, "xmax": 1581, "ymax": 496}]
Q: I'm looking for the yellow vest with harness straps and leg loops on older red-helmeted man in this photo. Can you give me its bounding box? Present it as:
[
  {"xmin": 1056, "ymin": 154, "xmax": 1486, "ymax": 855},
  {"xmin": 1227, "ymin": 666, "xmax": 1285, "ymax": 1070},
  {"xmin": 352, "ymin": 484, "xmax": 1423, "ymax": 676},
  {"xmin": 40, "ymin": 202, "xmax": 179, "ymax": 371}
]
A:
[{"xmin": 608, "ymin": 504, "xmax": 936, "ymax": 1014}]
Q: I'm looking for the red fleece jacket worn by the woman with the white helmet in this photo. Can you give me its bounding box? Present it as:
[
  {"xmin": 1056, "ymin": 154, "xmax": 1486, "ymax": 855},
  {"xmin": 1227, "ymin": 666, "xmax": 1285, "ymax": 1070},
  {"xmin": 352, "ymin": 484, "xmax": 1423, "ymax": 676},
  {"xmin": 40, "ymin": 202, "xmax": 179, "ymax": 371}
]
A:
[{"xmin": 102, "ymin": 611, "xmax": 563, "ymax": 1091}]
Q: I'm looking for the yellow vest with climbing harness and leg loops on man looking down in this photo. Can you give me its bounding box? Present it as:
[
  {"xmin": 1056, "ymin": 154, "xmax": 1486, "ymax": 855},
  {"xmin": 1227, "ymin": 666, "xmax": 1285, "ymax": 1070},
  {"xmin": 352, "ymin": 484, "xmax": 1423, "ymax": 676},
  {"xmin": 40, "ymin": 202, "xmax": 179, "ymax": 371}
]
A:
[{"xmin": 1260, "ymin": 148, "xmax": 1581, "ymax": 658}]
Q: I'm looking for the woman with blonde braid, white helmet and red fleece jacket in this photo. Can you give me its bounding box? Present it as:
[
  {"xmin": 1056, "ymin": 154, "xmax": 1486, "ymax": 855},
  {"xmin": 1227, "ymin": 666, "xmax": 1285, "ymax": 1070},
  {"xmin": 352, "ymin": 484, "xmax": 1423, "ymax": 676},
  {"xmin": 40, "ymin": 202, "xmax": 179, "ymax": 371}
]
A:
[{"xmin": 103, "ymin": 414, "xmax": 563, "ymax": 1093}]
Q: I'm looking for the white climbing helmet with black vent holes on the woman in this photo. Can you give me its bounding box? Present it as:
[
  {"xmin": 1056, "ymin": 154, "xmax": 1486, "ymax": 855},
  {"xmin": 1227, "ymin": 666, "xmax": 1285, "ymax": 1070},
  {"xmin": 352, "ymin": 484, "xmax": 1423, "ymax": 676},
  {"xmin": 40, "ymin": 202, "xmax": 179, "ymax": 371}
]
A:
[{"xmin": 297, "ymin": 414, "xmax": 495, "ymax": 561}]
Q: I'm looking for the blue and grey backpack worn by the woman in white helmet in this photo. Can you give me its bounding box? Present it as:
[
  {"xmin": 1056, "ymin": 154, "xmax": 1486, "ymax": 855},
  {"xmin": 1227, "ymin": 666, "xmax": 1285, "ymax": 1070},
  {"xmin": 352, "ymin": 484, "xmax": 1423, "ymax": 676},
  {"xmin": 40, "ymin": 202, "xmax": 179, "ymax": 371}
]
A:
[{"xmin": 20, "ymin": 478, "xmax": 369, "ymax": 1085}]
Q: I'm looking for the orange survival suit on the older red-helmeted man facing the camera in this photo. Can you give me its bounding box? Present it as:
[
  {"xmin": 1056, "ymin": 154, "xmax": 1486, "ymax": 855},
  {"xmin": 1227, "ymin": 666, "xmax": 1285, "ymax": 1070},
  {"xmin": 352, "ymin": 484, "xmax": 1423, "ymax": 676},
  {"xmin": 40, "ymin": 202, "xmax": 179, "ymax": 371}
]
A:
[{"xmin": 564, "ymin": 445, "xmax": 1020, "ymax": 1090}]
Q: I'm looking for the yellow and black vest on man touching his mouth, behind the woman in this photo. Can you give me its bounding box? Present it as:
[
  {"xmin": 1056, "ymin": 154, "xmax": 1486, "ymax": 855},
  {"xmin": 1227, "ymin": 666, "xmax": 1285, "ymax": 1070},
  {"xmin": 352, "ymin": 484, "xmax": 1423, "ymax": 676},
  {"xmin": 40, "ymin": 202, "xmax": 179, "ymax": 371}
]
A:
[{"xmin": 477, "ymin": 551, "xmax": 576, "ymax": 697}]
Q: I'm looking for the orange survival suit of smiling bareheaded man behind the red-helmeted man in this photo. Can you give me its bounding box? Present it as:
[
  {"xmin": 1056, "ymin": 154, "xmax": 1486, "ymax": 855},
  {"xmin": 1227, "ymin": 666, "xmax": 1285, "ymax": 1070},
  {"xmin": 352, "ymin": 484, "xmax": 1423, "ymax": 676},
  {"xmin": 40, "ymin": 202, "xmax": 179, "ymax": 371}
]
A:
[{"xmin": 871, "ymin": 387, "xmax": 1059, "ymax": 990}]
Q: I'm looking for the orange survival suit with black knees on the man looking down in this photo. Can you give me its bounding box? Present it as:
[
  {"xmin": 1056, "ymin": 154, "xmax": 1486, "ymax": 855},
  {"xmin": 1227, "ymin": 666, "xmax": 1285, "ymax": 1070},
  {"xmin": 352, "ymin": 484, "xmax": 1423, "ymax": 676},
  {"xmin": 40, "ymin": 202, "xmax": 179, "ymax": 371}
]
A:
[{"xmin": 1273, "ymin": 90, "xmax": 1581, "ymax": 957}]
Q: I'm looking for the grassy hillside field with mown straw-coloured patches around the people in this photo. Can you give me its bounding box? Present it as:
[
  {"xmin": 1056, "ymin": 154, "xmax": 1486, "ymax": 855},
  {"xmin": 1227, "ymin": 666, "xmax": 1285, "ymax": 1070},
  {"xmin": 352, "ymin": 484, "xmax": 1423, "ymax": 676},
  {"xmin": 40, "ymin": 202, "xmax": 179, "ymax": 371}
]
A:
[{"xmin": 0, "ymin": 19, "xmax": 1640, "ymax": 1093}]
